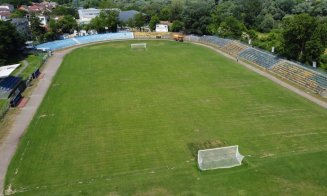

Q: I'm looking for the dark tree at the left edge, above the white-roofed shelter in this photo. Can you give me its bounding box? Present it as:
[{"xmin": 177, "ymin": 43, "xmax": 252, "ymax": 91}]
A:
[{"xmin": 0, "ymin": 20, "xmax": 24, "ymax": 66}]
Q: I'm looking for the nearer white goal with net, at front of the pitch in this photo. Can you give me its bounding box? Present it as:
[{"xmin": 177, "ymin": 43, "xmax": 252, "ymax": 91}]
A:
[{"xmin": 198, "ymin": 145, "xmax": 244, "ymax": 170}]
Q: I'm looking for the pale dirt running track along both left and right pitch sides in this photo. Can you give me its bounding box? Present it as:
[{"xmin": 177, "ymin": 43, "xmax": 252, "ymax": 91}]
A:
[{"xmin": 0, "ymin": 40, "xmax": 327, "ymax": 195}]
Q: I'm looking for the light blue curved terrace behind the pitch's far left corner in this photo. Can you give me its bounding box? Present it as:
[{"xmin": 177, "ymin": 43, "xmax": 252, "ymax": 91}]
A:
[{"xmin": 36, "ymin": 32, "xmax": 134, "ymax": 51}]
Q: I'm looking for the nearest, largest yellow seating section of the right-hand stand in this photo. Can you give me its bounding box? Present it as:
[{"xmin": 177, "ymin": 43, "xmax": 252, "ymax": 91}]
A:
[{"xmin": 271, "ymin": 61, "xmax": 327, "ymax": 93}]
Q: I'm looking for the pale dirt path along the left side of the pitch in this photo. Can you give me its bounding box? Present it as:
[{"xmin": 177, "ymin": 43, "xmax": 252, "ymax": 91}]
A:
[{"xmin": 0, "ymin": 49, "xmax": 72, "ymax": 195}]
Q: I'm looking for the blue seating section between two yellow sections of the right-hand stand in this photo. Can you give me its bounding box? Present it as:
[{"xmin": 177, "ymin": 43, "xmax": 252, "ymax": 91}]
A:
[{"xmin": 239, "ymin": 48, "xmax": 281, "ymax": 69}]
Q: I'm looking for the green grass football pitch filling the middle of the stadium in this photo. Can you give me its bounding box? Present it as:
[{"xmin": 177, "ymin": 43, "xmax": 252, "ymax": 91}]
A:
[{"xmin": 6, "ymin": 41, "xmax": 327, "ymax": 195}]
